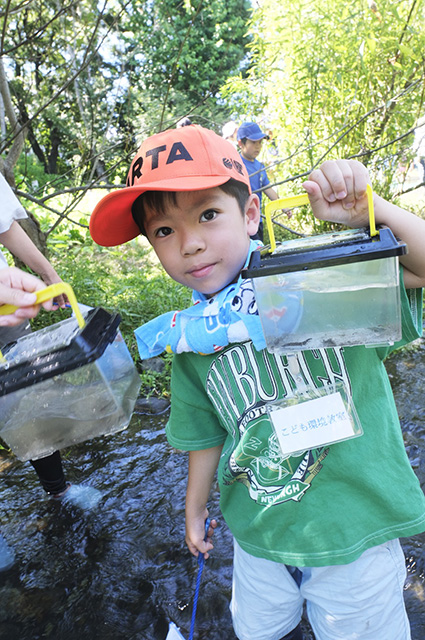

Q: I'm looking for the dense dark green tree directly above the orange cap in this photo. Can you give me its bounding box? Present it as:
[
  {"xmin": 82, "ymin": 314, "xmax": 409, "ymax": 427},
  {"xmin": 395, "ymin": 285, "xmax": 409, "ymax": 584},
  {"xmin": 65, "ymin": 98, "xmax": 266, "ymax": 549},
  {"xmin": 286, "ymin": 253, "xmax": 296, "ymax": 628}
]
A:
[{"xmin": 112, "ymin": 0, "xmax": 251, "ymax": 130}]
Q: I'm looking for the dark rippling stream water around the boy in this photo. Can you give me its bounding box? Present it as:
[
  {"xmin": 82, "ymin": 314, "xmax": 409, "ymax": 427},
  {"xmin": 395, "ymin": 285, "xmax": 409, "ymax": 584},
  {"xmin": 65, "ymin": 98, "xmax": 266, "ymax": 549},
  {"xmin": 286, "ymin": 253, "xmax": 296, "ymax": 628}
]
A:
[{"xmin": 0, "ymin": 342, "xmax": 425, "ymax": 640}]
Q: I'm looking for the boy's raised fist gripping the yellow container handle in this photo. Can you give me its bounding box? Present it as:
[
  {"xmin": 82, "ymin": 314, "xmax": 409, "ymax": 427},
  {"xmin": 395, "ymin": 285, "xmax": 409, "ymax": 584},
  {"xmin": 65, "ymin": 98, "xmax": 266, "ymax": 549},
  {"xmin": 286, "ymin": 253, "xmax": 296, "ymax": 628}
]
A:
[{"xmin": 303, "ymin": 160, "xmax": 369, "ymax": 227}]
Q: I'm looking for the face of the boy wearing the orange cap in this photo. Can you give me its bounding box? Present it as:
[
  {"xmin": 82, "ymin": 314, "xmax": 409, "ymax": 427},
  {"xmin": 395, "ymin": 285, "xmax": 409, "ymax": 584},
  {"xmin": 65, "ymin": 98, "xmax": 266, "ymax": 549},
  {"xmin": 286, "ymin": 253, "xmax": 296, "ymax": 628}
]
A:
[{"xmin": 145, "ymin": 187, "xmax": 260, "ymax": 295}]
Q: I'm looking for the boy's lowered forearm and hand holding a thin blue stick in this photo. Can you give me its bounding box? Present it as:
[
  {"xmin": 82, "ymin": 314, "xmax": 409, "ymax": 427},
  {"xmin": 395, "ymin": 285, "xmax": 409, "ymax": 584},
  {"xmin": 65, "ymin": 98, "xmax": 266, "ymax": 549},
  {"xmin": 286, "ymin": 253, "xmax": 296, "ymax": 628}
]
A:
[{"xmin": 186, "ymin": 445, "xmax": 222, "ymax": 559}]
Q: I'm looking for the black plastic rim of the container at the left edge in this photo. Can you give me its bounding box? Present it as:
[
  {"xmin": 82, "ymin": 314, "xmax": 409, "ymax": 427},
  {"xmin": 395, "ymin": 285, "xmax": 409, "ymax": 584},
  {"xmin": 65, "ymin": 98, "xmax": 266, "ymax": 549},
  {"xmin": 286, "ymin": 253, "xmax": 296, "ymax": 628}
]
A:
[{"xmin": 0, "ymin": 307, "xmax": 121, "ymax": 397}]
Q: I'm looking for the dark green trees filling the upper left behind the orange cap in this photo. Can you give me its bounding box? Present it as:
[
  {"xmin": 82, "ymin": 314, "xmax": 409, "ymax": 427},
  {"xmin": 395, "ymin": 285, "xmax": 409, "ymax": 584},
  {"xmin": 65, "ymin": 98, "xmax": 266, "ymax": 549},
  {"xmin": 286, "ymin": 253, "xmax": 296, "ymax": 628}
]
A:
[{"xmin": 0, "ymin": 0, "xmax": 251, "ymax": 205}]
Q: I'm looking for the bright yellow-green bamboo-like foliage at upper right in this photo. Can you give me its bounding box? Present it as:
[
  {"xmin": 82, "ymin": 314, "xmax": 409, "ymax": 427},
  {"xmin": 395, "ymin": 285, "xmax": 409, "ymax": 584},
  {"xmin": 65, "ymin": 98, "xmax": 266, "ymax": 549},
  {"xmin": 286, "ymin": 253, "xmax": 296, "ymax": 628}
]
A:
[{"xmin": 220, "ymin": 0, "xmax": 425, "ymax": 230}]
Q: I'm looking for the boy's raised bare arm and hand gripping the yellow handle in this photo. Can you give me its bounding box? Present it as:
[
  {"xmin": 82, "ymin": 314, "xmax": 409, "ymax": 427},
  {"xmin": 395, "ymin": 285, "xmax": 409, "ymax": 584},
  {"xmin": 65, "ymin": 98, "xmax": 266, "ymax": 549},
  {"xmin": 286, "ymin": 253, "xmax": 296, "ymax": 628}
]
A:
[{"xmin": 303, "ymin": 160, "xmax": 425, "ymax": 288}]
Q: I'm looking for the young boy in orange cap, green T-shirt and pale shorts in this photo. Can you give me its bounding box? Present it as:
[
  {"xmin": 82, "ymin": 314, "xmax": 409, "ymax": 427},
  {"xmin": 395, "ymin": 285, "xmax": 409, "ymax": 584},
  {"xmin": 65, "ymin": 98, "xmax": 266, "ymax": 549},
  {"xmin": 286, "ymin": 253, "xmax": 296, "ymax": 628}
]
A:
[{"xmin": 90, "ymin": 126, "xmax": 425, "ymax": 640}]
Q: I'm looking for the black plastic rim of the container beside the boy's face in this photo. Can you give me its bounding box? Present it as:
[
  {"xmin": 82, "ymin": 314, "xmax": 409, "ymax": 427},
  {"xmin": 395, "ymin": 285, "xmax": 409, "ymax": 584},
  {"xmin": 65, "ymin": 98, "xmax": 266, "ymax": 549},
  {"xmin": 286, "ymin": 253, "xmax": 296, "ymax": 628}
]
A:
[{"xmin": 241, "ymin": 227, "xmax": 407, "ymax": 278}]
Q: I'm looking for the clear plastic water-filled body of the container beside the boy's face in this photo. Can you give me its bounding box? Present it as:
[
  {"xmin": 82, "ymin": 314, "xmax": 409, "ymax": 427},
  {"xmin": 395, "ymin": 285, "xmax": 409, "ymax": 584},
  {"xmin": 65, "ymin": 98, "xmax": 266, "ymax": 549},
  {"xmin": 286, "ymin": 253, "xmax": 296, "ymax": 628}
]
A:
[{"xmin": 253, "ymin": 258, "xmax": 401, "ymax": 353}]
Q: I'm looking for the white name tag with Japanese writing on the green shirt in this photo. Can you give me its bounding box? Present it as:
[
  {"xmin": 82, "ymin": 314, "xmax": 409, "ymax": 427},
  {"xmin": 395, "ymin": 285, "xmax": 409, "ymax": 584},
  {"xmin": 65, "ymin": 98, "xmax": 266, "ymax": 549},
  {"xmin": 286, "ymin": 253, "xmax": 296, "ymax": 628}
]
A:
[{"xmin": 268, "ymin": 389, "xmax": 363, "ymax": 455}]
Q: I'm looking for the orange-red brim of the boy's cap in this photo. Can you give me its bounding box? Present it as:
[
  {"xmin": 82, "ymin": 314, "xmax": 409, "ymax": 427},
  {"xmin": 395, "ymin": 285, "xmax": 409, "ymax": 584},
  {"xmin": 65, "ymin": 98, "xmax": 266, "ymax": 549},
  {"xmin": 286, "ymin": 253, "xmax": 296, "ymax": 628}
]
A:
[{"xmin": 90, "ymin": 176, "xmax": 235, "ymax": 247}]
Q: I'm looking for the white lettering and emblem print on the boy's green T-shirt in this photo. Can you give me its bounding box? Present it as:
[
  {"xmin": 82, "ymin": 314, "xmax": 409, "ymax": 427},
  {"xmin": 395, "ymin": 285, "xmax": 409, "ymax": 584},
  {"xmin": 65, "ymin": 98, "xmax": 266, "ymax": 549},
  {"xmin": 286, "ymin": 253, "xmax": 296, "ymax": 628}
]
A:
[{"xmin": 206, "ymin": 343, "xmax": 350, "ymax": 504}]
